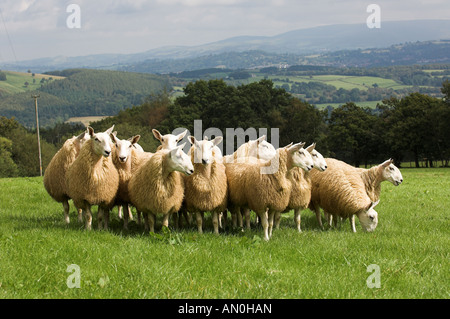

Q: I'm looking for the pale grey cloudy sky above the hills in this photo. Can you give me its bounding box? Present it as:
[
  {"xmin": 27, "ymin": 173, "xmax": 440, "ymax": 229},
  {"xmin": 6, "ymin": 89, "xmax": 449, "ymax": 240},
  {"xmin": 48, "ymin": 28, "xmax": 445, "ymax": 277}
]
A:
[{"xmin": 0, "ymin": 0, "xmax": 450, "ymax": 63}]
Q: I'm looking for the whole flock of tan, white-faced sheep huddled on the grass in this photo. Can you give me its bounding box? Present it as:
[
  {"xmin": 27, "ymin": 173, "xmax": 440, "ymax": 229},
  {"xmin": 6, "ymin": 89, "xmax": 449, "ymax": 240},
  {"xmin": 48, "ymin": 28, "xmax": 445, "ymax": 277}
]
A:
[{"xmin": 44, "ymin": 126, "xmax": 403, "ymax": 240}]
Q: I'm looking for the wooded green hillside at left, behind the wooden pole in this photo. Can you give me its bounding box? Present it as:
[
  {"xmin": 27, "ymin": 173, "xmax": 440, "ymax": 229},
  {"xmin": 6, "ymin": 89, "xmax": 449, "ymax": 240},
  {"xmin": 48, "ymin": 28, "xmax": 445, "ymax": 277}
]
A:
[{"xmin": 0, "ymin": 69, "xmax": 171, "ymax": 127}]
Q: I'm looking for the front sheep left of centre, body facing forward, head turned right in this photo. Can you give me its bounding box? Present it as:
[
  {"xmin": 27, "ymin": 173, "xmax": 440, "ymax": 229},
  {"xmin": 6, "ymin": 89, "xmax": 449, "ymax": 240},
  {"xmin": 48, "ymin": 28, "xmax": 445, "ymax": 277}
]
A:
[{"xmin": 128, "ymin": 143, "xmax": 194, "ymax": 232}]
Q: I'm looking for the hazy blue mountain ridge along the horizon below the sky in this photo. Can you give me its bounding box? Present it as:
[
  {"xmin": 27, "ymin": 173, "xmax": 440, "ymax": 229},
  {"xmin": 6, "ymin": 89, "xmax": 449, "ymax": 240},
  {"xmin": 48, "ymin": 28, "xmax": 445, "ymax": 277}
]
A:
[{"xmin": 0, "ymin": 20, "xmax": 450, "ymax": 72}]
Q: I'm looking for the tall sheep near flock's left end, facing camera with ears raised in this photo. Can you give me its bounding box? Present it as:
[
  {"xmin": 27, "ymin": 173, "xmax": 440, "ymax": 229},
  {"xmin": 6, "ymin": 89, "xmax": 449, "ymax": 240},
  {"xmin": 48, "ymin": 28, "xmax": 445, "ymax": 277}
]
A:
[{"xmin": 66, "ymin": 125, "xmax": 119, "ymax": 230}]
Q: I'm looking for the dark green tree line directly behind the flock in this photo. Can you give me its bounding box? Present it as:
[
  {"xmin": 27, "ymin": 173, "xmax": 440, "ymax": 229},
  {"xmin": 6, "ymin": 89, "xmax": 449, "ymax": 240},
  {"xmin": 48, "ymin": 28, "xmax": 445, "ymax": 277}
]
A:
[{"xmin": 0, "ymin": 80, "xmax": 450, "ymax": 176}]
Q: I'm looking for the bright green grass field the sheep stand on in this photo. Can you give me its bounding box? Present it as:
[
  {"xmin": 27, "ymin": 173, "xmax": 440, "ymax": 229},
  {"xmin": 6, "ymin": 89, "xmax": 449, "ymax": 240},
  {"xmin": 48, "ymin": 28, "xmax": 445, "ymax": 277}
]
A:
[{"xmin": 0, "ymin": 168, "xmax": 450, "ymax": 299}]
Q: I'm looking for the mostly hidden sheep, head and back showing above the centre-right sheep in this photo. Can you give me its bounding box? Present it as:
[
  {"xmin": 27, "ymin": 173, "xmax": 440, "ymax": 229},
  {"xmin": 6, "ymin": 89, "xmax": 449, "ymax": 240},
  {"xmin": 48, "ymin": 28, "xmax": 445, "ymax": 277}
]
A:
[{"xmin": 223, "ymin": 135, "xmax": 276, "ymax": 229}]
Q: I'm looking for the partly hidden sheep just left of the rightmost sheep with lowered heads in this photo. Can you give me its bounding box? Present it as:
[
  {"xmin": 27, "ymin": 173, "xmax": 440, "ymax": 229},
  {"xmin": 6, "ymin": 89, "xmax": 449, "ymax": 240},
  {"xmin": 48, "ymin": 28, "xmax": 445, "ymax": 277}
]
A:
[{"xmin": 275, "ymin": 143, "xmax": 328, "ymax": 232}]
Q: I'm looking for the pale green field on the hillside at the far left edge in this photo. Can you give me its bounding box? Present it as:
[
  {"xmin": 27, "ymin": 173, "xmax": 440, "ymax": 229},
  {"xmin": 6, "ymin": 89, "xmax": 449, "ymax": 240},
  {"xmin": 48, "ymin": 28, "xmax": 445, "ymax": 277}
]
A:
[{"xmin": 0, "ymin": 71, "xmax": 64, "ymax": 94}]
